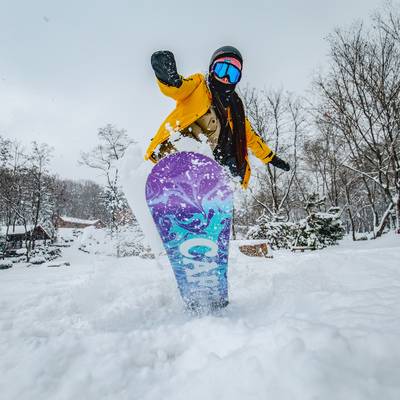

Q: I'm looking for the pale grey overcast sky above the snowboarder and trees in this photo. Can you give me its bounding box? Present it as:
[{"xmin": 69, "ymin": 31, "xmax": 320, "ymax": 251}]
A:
[{"xmin": 0, "ymin": 0, "xmax": 388, "ymax": 179}]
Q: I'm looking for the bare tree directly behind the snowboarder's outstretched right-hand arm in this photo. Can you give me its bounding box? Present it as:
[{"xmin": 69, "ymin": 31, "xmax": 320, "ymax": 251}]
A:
[{"xmin": 242, "ymin": 88, "xmax": 306, "ymax": 225}]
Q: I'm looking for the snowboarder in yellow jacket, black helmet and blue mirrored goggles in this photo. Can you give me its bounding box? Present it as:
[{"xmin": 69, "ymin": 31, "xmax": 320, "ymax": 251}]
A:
[{"xmin": 145, "ymin": 46, "xmax": 290, "ymax": 188}]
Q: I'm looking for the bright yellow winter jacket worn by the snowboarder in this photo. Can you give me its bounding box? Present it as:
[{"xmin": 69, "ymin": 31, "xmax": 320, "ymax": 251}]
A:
[{"xmin": 145, "ymin": 74, "xmax": 275, "ymax": 188}]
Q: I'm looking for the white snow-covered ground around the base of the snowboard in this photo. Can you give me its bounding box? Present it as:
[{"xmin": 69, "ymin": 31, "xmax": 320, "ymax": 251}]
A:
[{"xmin": 0, "ymin": 234, "xmax": 400, "ymax": 400}]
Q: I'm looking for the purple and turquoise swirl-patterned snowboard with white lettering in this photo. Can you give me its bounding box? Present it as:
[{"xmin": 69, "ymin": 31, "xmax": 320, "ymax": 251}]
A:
[{"xmin": 146, "ymin": 151, "xmax": 233, "ymax": 312}]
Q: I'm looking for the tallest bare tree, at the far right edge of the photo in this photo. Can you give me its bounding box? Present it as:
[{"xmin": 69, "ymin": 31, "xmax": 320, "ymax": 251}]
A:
[{"xmin": 316, "ymin": 18, "xmax": 400, "ymax": 236}]
